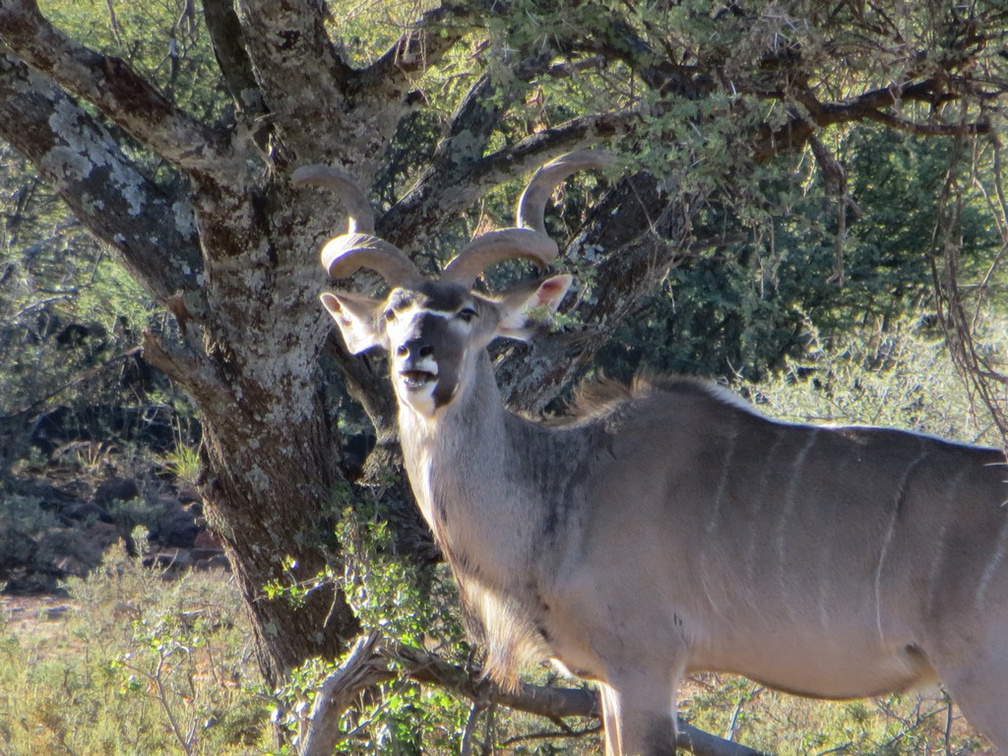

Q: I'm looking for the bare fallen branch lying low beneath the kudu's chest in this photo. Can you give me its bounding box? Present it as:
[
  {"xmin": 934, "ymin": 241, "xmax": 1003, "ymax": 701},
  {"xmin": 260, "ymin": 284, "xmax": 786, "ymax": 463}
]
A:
[{"xmin": 301, "ymin": 632, "xmax": 760, "ymax": 756}]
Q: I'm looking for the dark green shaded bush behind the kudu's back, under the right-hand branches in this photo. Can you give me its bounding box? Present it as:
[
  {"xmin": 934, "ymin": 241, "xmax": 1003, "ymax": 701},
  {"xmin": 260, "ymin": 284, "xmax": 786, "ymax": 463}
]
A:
[{"xmin": 599, "ymin": 128, "xmax": 1002, "ymax": 380}]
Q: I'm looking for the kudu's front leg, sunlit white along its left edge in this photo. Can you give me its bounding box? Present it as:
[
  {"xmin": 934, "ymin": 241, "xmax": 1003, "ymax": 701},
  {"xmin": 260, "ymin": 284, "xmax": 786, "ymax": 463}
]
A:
[{"xmin": 601, "ymin": 669, "xmax": 679, "ymax": 756}]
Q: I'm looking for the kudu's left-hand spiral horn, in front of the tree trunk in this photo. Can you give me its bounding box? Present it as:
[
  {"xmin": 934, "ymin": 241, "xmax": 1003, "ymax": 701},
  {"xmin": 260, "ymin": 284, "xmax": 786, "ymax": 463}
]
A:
[{"xmin": 292, "ymin": 165, "xmax": 422, "ymax": 286}]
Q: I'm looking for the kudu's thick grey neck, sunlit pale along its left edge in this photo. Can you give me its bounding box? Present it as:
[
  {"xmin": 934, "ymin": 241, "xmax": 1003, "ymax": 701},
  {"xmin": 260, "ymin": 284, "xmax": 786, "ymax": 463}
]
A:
[{"xmin": 399, "ymin": 344, "xmax": 591, "ymax": 595}]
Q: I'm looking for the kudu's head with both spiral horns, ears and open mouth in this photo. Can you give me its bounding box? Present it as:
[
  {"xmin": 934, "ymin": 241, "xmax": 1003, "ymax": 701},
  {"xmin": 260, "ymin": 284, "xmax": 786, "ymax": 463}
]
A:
[{"xmin": 293, "ymin": 150, "xmax": 611, "ymax": 419}]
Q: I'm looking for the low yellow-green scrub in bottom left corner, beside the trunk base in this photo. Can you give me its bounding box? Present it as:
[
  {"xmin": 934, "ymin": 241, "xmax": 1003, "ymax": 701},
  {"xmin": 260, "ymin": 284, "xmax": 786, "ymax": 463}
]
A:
[{"xmin": 0, "ymin": 544, "xmax": 269, "ymax": 756}]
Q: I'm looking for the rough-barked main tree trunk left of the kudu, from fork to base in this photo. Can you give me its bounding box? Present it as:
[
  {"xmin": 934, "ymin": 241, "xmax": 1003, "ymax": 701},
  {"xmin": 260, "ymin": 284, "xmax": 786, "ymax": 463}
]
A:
[{"xmin": 134, "ymin": 173, "xmax": 370, "ymax": 686}]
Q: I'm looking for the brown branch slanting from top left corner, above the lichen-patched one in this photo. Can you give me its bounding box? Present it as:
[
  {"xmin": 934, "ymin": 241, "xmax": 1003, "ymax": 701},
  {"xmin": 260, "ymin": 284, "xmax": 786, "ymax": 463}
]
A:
[{"xmin": 0, "ymin": 0, "xmax": 240, "ymax": 180}]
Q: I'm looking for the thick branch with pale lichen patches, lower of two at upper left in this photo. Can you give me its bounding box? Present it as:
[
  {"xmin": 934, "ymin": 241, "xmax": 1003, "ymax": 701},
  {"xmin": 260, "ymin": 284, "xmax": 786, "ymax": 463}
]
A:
[{"xmin": 0, "ymin": 55, "xmax": 202, "ymax": 301}]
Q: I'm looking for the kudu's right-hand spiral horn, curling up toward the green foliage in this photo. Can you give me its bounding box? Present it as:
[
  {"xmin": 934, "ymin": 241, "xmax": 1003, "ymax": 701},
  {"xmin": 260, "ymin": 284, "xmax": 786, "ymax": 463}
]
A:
[{"xmin": 442, "ymin": 149, "xmax": 615, "ymax": 286}]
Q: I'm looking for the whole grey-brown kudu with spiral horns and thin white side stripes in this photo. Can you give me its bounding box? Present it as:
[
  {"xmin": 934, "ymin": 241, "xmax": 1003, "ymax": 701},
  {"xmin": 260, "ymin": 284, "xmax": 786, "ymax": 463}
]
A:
[{"xmin": 294, "ymin": 151, "xmax": 1008, "ymax": 756}]
